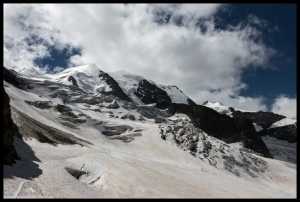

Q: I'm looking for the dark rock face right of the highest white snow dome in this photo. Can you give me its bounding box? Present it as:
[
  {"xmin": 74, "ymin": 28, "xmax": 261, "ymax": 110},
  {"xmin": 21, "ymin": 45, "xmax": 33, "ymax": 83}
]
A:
[{"xmin": 99, "ymin": 70, "xmax": 132, "ymax": 102}]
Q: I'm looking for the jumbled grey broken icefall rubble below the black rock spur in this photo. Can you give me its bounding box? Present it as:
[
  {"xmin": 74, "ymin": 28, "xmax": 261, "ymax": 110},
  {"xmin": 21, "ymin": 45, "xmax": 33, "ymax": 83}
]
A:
[{"xmin": 159, "ymin": 119, "xmax": 268, "ymax": 178}]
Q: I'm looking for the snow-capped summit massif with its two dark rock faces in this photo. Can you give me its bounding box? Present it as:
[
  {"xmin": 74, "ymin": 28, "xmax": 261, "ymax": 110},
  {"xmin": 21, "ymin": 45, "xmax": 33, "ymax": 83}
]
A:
[{"xmin": 42, "ymin": 64, "xmax": 195, "ymax": 104}]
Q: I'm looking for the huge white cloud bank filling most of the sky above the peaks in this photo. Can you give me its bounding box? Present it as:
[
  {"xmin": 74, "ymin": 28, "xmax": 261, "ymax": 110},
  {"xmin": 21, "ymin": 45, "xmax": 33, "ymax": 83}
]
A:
[{"xmin": 4, "ymin": 4, "xmax": 275, "ymax": 110}]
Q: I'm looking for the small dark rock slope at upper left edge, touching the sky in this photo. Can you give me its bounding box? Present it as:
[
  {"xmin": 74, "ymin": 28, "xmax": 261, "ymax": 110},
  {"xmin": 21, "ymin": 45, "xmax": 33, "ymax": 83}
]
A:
[{"xmin": 3, "ymin": 67, "xmax": 31, "ymax": 90}]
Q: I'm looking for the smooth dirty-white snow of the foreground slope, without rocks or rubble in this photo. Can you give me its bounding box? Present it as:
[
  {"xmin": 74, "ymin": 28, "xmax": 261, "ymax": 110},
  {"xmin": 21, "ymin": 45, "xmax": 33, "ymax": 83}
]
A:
[{"xmin": 3, "ymin": 78, "xmax": 296, "ymax": 198}]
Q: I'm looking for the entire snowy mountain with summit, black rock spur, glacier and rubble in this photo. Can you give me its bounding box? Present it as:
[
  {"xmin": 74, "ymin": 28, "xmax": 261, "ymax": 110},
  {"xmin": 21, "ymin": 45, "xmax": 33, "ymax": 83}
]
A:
[{"xmin": 3, "ymin": 64, "xmax": 296, "ymax": 198}]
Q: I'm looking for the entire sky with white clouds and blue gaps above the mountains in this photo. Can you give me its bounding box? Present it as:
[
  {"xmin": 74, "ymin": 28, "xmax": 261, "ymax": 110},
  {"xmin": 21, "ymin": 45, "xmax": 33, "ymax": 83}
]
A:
[{"xmin": 3, "ymin": 4, "xmax": 297, "ymax": 118}]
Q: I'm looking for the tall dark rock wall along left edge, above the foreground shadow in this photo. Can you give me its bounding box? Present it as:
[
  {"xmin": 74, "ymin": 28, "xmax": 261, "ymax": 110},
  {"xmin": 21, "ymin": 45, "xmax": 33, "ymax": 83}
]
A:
[{"xmin": 2, "ymin": 86, "xmax": 20, "ymax": 165}]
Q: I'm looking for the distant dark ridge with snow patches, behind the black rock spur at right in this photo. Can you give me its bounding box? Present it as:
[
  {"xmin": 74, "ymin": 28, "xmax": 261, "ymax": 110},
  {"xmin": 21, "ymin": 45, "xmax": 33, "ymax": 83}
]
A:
[{"xmin": 203, "ymin": 102, "xmax": 297, "ymax": 163}]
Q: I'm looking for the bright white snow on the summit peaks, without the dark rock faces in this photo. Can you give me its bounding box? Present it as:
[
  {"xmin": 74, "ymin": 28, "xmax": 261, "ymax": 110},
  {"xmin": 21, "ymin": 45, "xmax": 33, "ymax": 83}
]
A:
[{"xmin": 42, "ymin": 64, "xmax": 189, "ymax": 105}]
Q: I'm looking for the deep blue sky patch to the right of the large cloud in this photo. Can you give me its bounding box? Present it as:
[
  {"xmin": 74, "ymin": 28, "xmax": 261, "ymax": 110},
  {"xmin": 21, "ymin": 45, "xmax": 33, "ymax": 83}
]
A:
[{"xmin": 220, "ymin": 4, "xmax": 297, "ymax": 110}]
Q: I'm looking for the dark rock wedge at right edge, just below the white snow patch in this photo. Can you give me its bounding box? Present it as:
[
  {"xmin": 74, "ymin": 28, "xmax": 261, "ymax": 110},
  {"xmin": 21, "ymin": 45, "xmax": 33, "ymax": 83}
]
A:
[{"xmin": 258, "ymin": 124, "xmax": 297, "ymax": 143}]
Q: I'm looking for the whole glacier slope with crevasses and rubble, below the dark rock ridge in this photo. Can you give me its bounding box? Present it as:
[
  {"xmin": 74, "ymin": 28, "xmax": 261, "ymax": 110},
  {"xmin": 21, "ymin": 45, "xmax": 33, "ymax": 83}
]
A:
[{"xmin": 3, "ymin": 66, "xmax": 296, "ymax": 198}]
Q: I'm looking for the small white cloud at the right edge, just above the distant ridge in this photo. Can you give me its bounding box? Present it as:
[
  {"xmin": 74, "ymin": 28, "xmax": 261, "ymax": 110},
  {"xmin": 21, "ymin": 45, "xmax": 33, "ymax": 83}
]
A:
[{"xmin": 271, "ymin": 94, "xmax": 297, "ymax": 118}]
